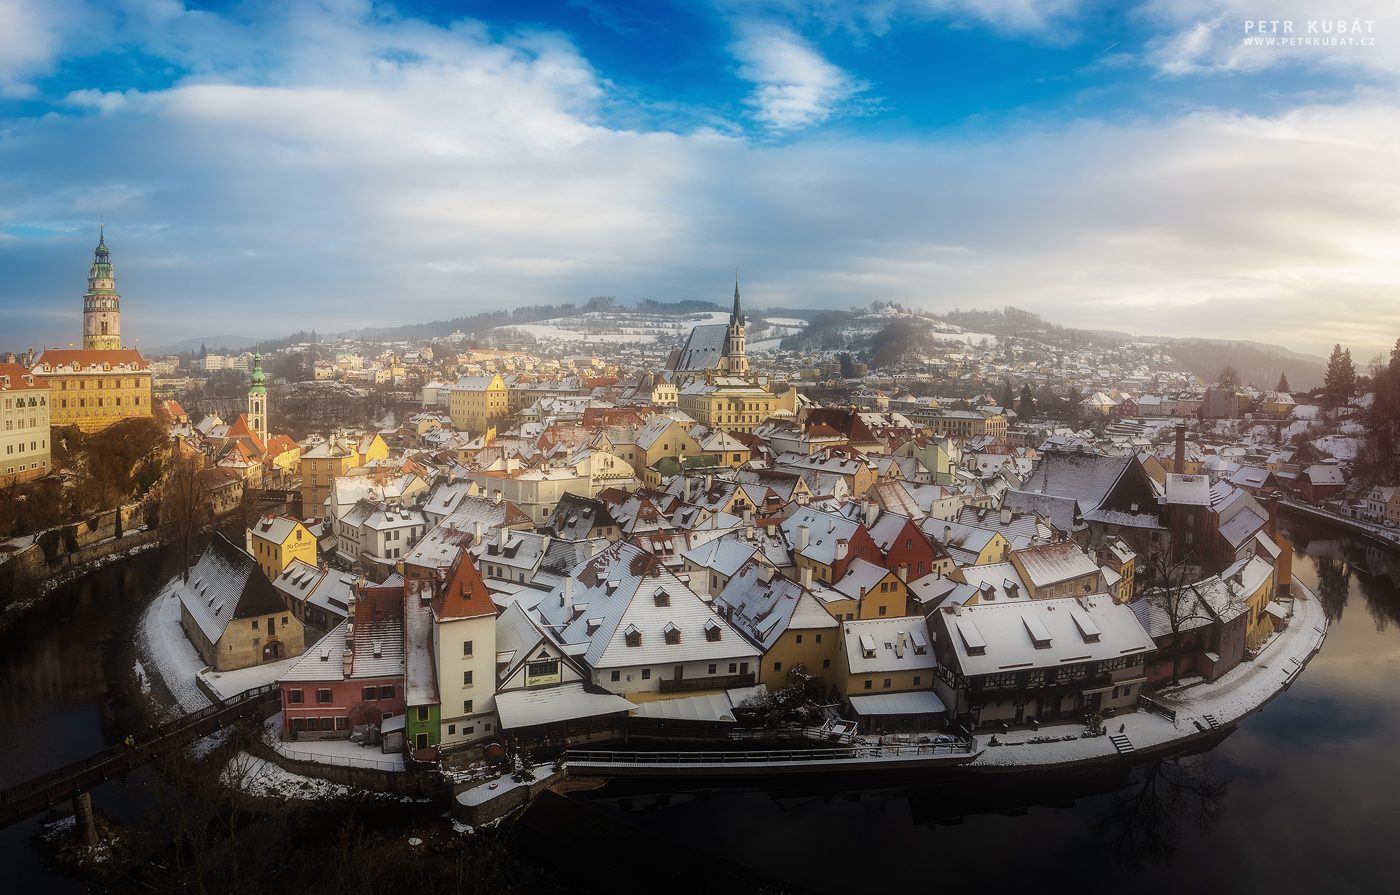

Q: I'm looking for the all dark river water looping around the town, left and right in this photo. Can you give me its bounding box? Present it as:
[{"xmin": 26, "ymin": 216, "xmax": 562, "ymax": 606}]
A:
[{"xmin": 0, "ymin": 527, "xmax": 1400, "ymax": 894}]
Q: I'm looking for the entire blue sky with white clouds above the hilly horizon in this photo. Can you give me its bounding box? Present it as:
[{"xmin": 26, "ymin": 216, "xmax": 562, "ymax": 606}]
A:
[{"xmin": 0, "ymin": 0, "xmax": 1400, "ymax": 359}]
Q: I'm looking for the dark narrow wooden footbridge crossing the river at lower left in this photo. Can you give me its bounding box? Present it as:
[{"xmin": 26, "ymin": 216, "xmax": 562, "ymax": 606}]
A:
[{"xmin": 0, "ymin": 684, "xmax": 281, "ymax": 828}]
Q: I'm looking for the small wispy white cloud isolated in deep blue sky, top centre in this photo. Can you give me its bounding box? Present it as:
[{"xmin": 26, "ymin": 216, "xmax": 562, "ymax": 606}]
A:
[{"xmin": 732, "ymin": 22, "xmax": 867, "ymax": 132}]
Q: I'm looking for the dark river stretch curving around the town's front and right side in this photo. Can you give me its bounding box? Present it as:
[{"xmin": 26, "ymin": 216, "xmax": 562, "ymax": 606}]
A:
[{"xmin": 575, "ymin": 524, "xmax": 1400, "ymax": 894}]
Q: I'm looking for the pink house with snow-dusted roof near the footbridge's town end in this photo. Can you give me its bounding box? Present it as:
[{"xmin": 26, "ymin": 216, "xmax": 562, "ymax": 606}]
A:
[{"xmin": 279, "ymin": 585, "xmax": 405, "ymax": 740}]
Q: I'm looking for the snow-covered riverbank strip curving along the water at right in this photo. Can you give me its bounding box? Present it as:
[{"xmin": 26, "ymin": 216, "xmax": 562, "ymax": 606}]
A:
[{"xmin": 973, "ymin": 577, "xmax": 1327, "ymax": 768}]
